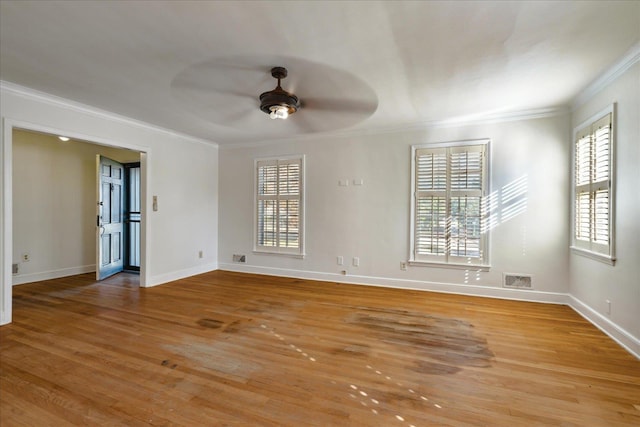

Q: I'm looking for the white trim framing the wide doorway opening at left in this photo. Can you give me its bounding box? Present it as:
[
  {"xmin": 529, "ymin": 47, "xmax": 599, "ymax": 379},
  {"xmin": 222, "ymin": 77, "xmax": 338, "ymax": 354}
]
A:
[{"xmin": 0, "ymin": 117, "xmax": 152, "ymax": 325}]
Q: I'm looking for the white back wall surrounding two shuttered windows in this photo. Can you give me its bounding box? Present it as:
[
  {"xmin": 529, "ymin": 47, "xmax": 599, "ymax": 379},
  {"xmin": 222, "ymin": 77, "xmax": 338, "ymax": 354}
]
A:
[{"xmin": 219, "ymin": 115, "xmax": 570, "ymax": 302}]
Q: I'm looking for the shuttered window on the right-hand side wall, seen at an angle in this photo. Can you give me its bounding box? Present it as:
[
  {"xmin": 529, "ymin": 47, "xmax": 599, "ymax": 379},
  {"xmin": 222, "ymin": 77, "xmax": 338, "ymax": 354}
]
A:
[{"xmin": 572, "ymin": 106, "xmax": 614, "ymax": 263}]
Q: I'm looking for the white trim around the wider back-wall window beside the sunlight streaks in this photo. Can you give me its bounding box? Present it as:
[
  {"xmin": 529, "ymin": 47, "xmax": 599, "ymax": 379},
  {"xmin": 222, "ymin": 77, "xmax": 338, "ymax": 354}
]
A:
[{"xmin": 408, "ymin": 138, "xmax": 491, "ymax": 271}]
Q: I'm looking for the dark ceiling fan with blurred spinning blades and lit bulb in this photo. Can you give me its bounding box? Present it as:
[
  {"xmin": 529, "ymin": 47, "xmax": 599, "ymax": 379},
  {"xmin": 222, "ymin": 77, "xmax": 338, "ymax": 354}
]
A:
[{"xmin": 171, "ymin": 55, "xmax": 378, "ymax": 138}]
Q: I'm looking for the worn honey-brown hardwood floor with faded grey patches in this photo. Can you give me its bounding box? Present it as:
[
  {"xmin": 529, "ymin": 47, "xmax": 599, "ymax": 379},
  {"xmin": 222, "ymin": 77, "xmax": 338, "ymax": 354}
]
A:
[{"xmin": 0, "ymin": 271, "xmax": 640, "ymax": 427}]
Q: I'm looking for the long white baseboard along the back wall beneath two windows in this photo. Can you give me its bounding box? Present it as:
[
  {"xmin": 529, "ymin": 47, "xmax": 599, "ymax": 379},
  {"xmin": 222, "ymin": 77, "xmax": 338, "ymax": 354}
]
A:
[{"xmin": 219, "ymin": 263, "xmax": 568, "ymax": 305}]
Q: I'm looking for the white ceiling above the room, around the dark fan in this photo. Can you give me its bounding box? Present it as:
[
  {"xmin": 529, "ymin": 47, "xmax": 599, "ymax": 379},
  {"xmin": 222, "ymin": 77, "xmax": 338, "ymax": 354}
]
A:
[{"xmin": 0, "ymin": 0, "xmax": 640, "ymax": 144}]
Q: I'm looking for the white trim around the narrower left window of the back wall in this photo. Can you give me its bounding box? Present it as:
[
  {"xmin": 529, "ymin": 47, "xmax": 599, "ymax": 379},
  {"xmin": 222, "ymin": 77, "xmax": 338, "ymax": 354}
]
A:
[{"xmin": 253, "ymin": 154, "xmax": 306, "ymax": 258}]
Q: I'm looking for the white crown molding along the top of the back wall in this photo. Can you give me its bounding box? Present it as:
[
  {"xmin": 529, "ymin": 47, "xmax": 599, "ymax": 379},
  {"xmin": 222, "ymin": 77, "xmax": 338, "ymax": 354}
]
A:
[{"xmin": 220, "ymin": 106, "xmax": 570, "ymax": 150}]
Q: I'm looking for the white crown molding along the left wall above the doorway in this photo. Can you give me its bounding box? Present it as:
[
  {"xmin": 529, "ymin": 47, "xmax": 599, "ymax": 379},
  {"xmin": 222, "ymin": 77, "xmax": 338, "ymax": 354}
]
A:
[{"xmin": 0, "ymin": 80, "xmax": 218, "ymax": 148}]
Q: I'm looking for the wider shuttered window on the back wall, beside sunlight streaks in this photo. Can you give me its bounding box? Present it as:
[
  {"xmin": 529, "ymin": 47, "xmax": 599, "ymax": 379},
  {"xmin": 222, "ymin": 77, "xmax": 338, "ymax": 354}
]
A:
[{"xmin": 411, "ymin": 140, "xmax": 488, "ymax": 265}]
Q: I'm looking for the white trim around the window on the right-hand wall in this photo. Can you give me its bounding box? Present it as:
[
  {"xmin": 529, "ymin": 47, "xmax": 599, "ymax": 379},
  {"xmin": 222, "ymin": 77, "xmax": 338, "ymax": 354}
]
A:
[{"xmin": 569, "ymin": 103, "xmax": 617, "ymax": 265}]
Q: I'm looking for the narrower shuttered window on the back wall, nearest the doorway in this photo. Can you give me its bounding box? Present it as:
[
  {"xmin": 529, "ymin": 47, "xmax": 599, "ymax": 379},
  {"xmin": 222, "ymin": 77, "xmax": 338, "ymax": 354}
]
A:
[{"xmin": 255, "ymin": 157, "xmax": 304, "ymax": 255}]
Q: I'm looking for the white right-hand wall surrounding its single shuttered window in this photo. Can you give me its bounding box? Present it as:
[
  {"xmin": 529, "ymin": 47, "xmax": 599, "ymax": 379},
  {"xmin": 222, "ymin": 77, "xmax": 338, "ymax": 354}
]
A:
[{"xmin": 569, "ymin": 61, "xmax": 640, "ymax": 354}]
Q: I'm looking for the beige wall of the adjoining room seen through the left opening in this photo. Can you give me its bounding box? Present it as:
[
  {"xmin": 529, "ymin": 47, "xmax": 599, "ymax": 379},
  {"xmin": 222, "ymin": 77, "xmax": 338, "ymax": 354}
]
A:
[{"xmin": 13, "ymin": 130, "xmax": 140, "ymax": 285}]
